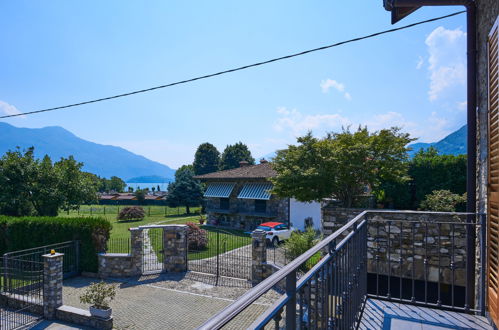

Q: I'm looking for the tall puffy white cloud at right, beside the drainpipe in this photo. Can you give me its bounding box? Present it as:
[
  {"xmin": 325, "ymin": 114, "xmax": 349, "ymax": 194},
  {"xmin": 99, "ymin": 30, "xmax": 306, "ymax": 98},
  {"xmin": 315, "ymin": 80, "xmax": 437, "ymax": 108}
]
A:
[{"xmin": 425, "ymin": 26, "xmax": 466, "ymax": 101}]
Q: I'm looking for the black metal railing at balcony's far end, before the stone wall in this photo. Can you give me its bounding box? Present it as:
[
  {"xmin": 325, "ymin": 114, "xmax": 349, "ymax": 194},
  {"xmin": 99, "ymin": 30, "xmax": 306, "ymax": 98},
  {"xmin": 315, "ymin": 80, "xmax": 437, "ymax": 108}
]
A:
[{"xmin": 367, "ymin": 213, "xmax": 480, "ymax": 312}]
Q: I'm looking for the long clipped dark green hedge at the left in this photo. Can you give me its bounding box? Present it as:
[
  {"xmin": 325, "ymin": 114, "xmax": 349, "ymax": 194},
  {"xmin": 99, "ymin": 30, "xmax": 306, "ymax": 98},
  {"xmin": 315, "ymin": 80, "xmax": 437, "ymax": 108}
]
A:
[{"xmin": 0, "ymin": 216, "xmax": 112, "ymax": 272}]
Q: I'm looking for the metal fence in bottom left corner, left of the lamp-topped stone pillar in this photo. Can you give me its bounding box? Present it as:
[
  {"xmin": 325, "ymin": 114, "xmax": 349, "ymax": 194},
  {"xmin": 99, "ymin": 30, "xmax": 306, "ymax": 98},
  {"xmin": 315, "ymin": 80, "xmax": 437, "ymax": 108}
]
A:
[{"xmin": 0, "ymin": 258, "xmax": 43, "ymax": 330}]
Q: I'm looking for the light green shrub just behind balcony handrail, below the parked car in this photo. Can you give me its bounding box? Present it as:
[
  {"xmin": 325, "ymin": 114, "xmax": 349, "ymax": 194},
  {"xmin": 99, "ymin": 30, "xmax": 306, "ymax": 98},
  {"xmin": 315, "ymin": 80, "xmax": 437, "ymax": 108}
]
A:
[{"xmin": 284, "ymin": 227, "xmax": 321, "ymax": 271}]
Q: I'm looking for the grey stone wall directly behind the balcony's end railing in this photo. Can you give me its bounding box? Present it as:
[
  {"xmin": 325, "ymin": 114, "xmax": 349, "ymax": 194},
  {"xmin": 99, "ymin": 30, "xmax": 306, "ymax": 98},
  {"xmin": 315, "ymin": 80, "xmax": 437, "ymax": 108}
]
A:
[{"xmin": 323, "ymin": 208, "xmax": 466, "ymax": 286}]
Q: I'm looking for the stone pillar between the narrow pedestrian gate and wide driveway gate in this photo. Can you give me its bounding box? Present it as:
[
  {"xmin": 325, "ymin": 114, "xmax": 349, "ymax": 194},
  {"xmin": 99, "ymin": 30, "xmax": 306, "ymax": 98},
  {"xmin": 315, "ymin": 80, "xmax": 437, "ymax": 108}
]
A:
[{"xmin": 163, "ymin": 225, "xmax": 187, "ymax": 273}]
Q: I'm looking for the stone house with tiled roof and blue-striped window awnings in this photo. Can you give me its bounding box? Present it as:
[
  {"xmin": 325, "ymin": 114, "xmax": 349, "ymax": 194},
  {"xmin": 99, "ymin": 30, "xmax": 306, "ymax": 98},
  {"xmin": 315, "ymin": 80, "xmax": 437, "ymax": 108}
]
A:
[{"xmin": 195, "ymin": 160, "xmax": 321, "ymax": 230}]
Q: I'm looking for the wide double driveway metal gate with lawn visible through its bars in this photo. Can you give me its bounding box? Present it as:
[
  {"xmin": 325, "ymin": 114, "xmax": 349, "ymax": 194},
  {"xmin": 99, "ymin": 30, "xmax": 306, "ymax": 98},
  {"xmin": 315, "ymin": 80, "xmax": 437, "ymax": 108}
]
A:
[{"xmin": 188, "ymin": 226, "xmax": 252, "ymax": 283}]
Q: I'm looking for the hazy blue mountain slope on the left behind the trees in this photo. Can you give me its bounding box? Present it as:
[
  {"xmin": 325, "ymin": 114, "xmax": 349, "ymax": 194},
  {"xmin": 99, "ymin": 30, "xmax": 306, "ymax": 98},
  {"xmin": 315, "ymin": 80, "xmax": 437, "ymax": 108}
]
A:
[{"xmin": 0, "ymin": 122, "xmax": 175, "ymax": 181}]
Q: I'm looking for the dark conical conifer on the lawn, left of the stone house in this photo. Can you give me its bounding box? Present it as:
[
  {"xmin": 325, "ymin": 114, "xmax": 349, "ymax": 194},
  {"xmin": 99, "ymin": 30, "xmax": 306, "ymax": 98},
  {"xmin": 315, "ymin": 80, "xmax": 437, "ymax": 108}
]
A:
[{"xmin": 166, "ymin": 165, "xmax": 203, "ymax": 214}]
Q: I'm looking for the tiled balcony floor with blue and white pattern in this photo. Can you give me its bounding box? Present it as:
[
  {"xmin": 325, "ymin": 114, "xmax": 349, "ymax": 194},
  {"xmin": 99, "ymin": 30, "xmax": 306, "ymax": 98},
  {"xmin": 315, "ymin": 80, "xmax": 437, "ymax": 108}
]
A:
[{"xmin": 359, "ymin": 299, "xmax": 493, "ymax": 330}]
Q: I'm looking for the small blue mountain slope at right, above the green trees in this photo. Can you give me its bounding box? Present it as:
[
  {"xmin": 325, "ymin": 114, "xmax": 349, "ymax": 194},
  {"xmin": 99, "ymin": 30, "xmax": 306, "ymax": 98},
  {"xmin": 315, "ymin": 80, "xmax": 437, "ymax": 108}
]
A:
[{"xmin": 408, "ymin": 125, "xmax": 468, "ymax": 157}]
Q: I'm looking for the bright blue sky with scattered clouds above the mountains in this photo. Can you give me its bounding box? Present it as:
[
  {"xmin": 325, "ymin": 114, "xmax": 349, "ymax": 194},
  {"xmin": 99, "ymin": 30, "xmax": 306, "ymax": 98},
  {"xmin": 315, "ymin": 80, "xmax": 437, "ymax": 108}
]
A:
[{"xmin": 0, "ymin": 0, "xmax": 466, "ymax": 168}]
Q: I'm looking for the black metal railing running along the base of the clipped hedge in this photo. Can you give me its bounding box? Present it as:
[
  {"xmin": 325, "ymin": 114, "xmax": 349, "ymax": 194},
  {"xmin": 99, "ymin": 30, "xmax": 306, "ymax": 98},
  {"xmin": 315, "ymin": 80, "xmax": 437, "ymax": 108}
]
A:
[{"xmin": 3, "ymin": 241, "xmax": 80, "ymax": 278}]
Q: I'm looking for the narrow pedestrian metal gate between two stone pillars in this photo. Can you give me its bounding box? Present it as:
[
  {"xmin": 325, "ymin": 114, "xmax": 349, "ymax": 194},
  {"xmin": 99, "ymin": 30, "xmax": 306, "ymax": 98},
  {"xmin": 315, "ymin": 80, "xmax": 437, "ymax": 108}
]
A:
[{"xmin": 142, "ymin": 228, "xmax": 164, "ymax": 274}]
